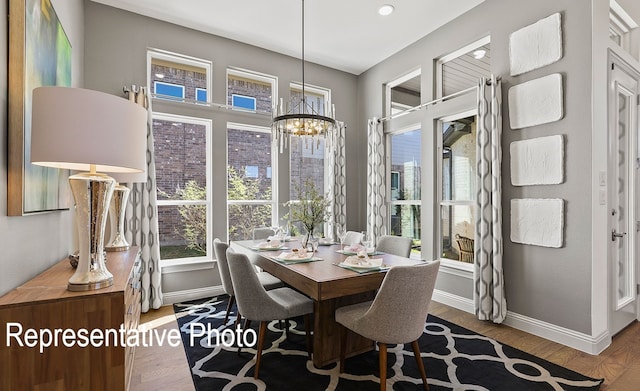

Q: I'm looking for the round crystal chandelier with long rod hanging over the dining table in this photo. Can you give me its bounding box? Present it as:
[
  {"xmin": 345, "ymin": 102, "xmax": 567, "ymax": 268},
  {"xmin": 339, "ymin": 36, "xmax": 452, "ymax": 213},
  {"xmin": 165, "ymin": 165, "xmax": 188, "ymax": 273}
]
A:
[{"xmin": 271, "ymin": 0, "xmax": 337, "ymax": 153}]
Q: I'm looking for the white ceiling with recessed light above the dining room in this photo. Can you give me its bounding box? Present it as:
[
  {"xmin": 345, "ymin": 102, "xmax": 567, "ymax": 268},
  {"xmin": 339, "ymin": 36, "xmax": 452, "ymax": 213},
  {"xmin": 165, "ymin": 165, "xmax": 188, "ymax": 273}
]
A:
[{"xmin": 92, "ymin": 0, "xmax": 484, "ymax": 75}]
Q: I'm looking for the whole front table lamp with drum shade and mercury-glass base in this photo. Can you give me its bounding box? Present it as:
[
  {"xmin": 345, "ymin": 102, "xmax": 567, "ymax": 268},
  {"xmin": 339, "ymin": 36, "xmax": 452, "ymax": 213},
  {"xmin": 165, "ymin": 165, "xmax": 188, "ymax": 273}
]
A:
[{"xmin": 31, "ymin": 87, "xmax": 147, "ymax": 291}]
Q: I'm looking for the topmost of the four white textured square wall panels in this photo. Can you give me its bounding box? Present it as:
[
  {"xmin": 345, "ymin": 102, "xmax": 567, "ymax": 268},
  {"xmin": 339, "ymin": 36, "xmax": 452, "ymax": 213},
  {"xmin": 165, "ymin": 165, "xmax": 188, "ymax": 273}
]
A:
[{"xmin": 509, "ymin": 13, "xmax": 562, "ymax": 76}]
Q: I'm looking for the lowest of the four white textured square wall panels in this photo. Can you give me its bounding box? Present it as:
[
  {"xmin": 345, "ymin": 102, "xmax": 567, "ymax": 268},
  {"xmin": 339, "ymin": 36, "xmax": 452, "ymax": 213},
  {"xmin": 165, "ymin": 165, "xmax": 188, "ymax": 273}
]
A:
[{"xmin": 511, "ymin": 199, "xmax": 564, "ymax": 248}]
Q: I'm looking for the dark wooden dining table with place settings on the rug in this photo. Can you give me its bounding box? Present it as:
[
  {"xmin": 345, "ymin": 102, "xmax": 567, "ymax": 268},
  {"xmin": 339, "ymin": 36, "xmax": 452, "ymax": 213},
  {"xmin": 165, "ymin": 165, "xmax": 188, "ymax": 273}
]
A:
[{"xmin": 231, "ymin": 239, "xmax": 423, "ymax": 367}]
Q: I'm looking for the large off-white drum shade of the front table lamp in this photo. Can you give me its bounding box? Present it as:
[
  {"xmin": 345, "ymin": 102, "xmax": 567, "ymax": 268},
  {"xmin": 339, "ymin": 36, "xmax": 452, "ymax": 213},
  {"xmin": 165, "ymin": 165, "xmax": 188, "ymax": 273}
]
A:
[{"xmin": 31, "ymin": 87, "xmax": 147, "ymax": 174}]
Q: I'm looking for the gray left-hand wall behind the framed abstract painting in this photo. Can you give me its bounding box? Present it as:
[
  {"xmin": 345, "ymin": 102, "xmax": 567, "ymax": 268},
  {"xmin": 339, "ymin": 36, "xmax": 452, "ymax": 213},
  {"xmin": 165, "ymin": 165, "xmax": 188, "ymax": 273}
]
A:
[{"xmin": 0, "ymin": 0, "xmax": 84, "ymax": 295}]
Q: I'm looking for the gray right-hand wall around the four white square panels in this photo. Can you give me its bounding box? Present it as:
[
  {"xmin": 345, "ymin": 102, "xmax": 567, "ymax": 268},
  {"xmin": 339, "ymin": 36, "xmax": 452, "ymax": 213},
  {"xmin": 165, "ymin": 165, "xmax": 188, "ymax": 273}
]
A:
[{"xmin": 357, "ymin": 0, "xmax": 591, "ymax": 334}]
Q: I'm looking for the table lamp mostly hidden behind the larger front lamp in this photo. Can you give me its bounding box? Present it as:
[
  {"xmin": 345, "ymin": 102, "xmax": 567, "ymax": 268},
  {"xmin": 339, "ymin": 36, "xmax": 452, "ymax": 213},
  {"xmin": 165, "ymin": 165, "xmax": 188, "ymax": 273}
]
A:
[{"xmin": 104, "ymin": 171, "xmax": 147, "ymax": 251}]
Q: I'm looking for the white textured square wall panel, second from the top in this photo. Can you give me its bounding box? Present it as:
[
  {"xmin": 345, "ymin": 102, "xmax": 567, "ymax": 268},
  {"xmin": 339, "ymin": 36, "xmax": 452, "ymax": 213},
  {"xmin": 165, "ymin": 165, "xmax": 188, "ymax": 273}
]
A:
[{"xmin": 509, "ymin": 73, "xmax": 564, "ymax": 129}]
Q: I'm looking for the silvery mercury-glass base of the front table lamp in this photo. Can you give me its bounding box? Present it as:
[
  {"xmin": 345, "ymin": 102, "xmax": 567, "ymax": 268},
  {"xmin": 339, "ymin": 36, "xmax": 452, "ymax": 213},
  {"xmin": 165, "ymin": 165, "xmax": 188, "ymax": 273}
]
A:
[{"xmin": 67, "ymin": 172, "xmax": 116, "ymax": 292}]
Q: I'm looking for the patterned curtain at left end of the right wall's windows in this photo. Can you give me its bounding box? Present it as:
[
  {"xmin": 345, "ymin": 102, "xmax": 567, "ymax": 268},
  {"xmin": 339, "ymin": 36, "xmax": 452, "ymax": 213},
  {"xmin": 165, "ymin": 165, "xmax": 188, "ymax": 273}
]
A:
[{"xmin": 367, "ymin": 118, "xmax": 387, "ymax": 243}]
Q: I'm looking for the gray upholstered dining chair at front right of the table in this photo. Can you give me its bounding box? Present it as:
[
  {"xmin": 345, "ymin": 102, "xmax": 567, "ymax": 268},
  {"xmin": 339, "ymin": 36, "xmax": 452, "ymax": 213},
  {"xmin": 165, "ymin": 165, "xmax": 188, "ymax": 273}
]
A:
[{"xmin": 335, "ymin": 261, "xmax": 440, "ymax": 391}]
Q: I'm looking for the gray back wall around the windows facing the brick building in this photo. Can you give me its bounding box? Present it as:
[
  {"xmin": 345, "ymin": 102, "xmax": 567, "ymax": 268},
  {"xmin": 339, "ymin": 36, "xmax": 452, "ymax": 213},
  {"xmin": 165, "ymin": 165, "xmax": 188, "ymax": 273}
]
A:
[{"xmin": 85, "ymin": 1, "xmax": 366, "ymax": 291}]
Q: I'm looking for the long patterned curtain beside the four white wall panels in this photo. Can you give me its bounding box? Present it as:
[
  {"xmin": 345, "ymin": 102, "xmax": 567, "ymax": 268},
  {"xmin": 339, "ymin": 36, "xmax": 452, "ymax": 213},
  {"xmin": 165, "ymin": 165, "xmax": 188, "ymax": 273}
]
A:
[{"xmin": 474, "ymin": 76, "xmax": 507, "ymax": 323}]
